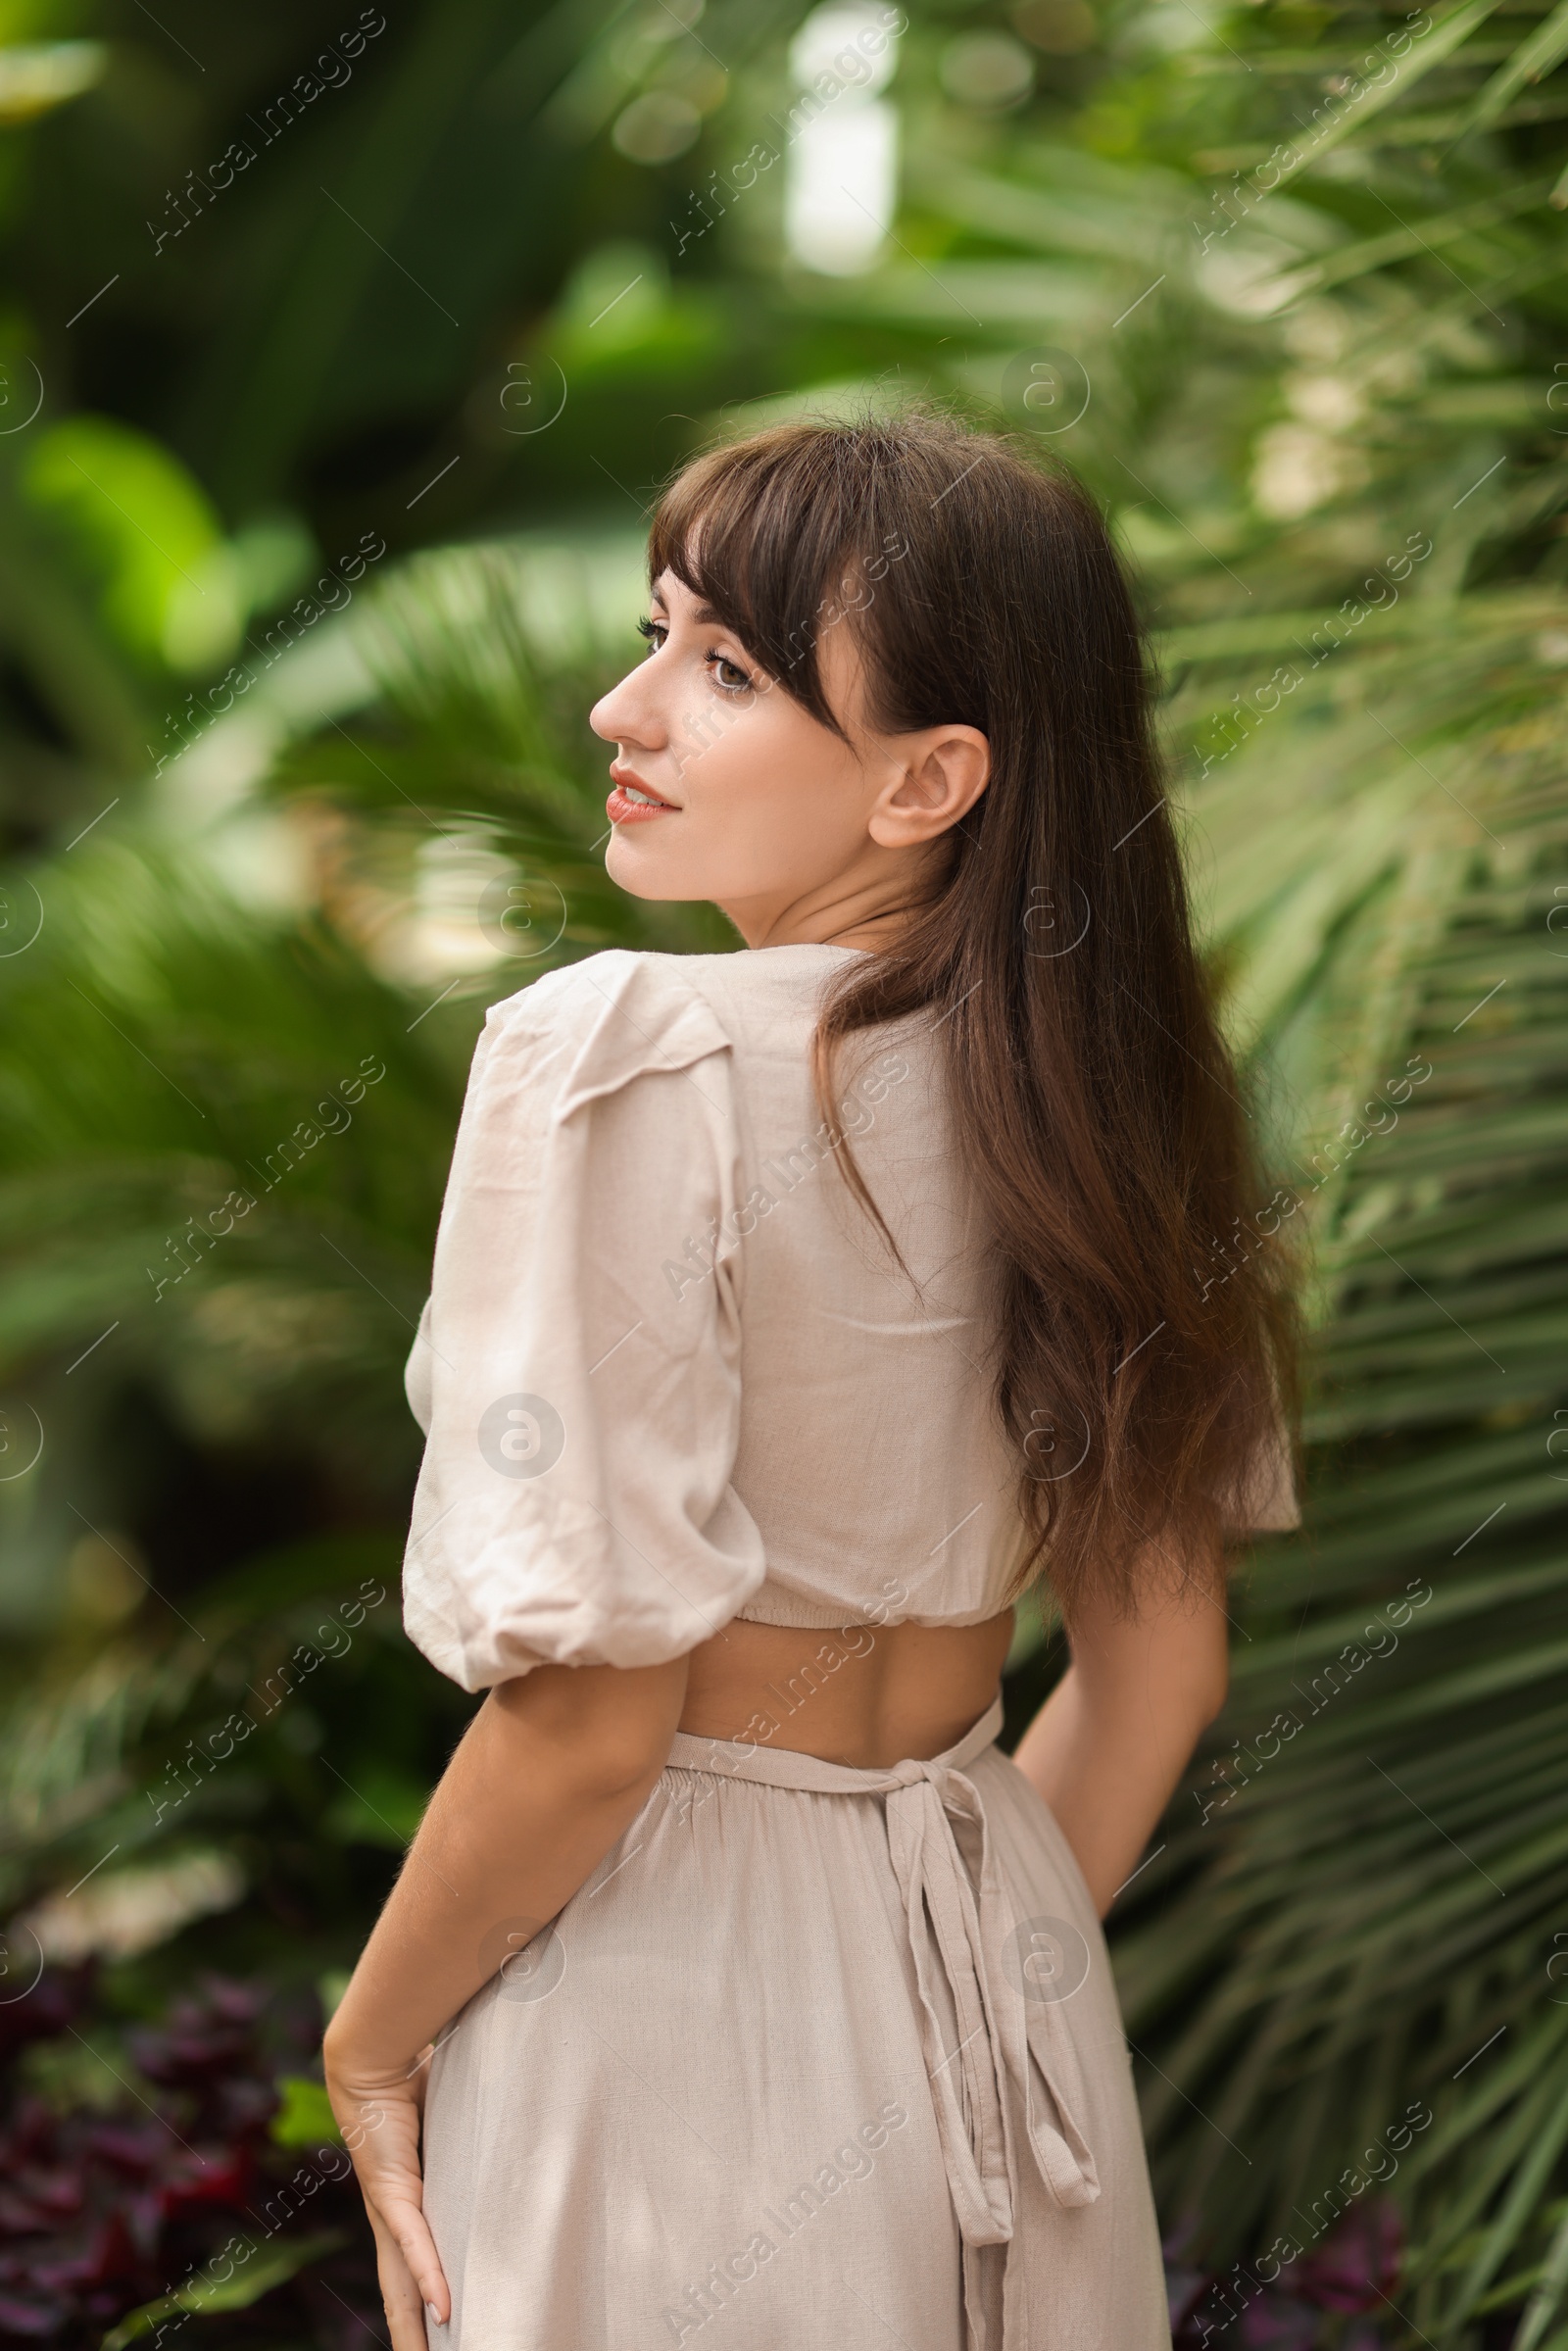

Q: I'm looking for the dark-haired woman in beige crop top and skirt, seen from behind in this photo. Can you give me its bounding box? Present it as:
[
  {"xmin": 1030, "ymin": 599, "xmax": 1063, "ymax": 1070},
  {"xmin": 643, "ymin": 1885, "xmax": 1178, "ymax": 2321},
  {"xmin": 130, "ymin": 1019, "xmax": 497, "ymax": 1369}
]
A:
[{"xmin": 326, "ymin": 416, "xmax": 1296, "ymax": 2351}]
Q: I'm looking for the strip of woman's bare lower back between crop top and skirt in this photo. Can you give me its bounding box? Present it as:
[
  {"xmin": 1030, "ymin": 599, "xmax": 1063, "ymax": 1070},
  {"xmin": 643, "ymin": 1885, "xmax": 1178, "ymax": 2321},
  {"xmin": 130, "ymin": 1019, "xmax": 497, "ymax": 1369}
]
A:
[{"xmin": 679, "ymin": 1608, "xmax": 1013, "ymax": 1770}]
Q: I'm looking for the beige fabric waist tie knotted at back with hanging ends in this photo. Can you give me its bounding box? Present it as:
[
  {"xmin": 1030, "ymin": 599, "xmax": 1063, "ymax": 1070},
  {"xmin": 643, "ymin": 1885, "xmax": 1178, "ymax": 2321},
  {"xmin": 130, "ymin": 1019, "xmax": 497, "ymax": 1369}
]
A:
[{"xmin": 670, "ymin": 1697, "xmax": 1101, "ymax": 2331}]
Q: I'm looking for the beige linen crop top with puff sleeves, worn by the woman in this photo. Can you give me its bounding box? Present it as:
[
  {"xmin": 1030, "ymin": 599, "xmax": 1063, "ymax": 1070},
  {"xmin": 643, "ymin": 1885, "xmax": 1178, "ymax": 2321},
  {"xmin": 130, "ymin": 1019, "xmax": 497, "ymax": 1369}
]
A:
[{"xmin": 405, "ymin": 945, "xmax": 1298, "ymax": 1690}]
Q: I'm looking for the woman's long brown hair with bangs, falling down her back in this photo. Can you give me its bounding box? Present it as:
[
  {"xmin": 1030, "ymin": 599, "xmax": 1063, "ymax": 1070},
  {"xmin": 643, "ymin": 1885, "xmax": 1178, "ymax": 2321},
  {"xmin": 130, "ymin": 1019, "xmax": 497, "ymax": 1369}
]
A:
[{"xmin": 649, "ymin": 412, "xmax": 1296, "ymax": 1618}]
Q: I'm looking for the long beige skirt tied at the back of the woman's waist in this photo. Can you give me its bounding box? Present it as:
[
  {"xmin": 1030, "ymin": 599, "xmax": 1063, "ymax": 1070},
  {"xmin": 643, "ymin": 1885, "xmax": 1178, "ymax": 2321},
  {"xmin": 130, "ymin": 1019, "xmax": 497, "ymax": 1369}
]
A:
[{"xmin": 425, "ymin": 1702, "xmax": 1171, "ymax": 2351}]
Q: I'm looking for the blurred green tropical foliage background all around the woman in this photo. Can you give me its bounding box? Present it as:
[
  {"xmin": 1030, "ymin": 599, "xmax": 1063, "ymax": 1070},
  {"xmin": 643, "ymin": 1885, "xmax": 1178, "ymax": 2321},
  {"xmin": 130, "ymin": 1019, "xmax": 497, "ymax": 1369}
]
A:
[{"xmin": 0, "ymin": 0, "xmax": 1568, "ymax": 2351}]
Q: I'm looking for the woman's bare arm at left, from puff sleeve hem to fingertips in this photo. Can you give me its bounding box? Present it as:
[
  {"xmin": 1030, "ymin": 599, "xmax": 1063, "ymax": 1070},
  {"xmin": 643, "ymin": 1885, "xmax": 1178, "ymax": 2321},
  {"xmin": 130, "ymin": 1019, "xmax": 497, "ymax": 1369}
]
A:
[{"xmin": 322, "ymin": 1657, "xmax": 686, "ymax": 2351}]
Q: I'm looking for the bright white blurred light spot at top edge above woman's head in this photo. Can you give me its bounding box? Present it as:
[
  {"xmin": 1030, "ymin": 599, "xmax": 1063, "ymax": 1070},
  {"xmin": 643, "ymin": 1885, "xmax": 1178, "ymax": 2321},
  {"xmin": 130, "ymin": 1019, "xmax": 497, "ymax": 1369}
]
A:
[{"xmin": 785, "ymin": 0, "xmax": 901, "ymax": 277}]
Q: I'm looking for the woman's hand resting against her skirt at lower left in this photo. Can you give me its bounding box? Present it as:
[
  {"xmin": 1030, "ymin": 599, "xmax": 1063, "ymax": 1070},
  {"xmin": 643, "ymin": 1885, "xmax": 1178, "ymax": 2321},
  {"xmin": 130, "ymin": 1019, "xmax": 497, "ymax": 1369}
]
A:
[{"xmin": 324, "ymin": 2040, "xmax": 452, "ymax": 2351}]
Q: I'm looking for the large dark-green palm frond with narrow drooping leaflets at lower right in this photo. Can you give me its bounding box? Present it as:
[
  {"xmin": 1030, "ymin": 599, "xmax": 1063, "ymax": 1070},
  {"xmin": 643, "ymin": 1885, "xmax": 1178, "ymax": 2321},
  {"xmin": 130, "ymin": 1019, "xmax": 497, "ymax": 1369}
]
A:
[{"xmin": 1119, "ymin": 736, "xmax": 1568, "ymax": 2341}]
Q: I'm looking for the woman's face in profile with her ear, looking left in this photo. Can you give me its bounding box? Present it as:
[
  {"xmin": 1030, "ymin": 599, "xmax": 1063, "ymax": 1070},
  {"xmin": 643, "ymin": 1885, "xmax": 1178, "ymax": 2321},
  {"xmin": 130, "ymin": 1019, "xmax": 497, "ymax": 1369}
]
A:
[{"xmin": 590, "ymin": 571, "xmax": 990, "ymax": 948}]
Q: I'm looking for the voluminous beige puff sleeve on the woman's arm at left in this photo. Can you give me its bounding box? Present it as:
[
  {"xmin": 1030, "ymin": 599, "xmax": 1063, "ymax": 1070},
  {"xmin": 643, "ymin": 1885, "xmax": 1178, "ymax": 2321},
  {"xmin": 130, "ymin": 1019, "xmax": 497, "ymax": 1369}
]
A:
[{"xmin": 402, "ymin": 953, "xmax": 764, "ymax": 1690}]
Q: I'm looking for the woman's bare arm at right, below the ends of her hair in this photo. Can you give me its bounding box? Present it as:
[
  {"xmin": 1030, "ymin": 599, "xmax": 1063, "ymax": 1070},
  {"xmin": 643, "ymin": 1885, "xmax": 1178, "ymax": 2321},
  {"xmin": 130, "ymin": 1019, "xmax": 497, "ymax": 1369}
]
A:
[{"xmin": 1013, "ymin": 1561, "xmax": 1227, "ymax": 1916}]
